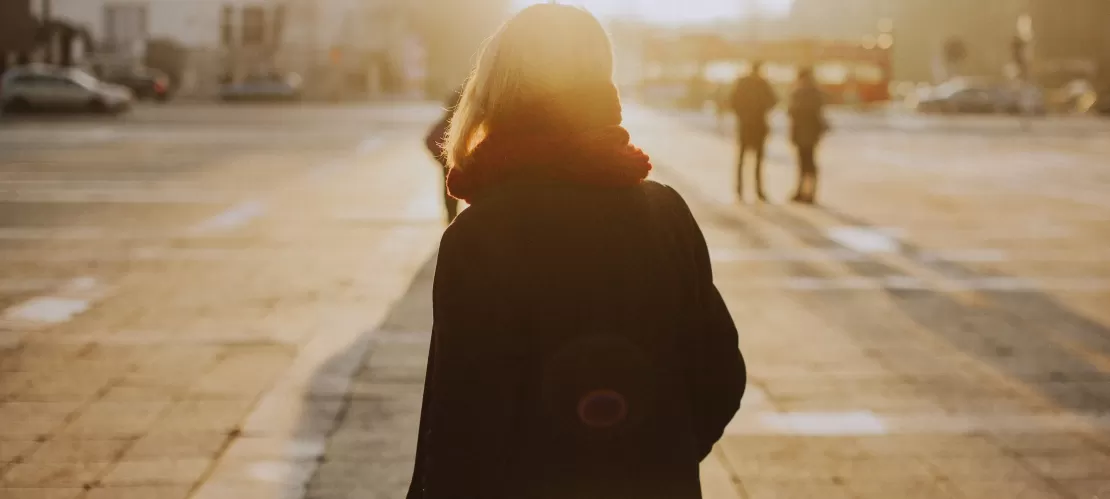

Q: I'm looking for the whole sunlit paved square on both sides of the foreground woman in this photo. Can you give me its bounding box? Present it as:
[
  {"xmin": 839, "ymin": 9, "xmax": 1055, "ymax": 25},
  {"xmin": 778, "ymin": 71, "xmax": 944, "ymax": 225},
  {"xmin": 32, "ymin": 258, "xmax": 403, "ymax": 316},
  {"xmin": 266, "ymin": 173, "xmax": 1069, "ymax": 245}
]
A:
[{"xmin": 0, "ymin": 103, "xmax": 1110, "ymax": 499}]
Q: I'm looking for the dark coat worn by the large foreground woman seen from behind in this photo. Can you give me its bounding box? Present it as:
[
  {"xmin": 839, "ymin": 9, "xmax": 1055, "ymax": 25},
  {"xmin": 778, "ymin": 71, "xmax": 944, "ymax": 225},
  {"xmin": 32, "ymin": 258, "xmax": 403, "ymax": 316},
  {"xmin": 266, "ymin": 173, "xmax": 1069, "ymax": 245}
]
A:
[{"xmin": 408, "ymin": 180, "xmax": 746, "ymax": 499}]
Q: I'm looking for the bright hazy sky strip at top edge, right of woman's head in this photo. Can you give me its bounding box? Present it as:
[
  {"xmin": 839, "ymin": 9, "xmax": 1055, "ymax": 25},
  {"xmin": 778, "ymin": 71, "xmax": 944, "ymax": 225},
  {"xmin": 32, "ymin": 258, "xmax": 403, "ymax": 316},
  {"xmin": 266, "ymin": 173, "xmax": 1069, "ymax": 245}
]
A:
[{"xmin": 515, "ymin": 0, "xmax": 794, "ymax": 23}]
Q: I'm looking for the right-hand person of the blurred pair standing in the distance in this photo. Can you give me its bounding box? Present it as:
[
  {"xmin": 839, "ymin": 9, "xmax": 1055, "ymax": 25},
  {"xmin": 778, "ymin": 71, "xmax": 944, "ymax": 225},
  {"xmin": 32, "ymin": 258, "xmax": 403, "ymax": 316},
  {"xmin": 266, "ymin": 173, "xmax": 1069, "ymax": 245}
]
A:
[{"xmin": 790, "ymin": 68, "xmax": 828, "ymax": 204}]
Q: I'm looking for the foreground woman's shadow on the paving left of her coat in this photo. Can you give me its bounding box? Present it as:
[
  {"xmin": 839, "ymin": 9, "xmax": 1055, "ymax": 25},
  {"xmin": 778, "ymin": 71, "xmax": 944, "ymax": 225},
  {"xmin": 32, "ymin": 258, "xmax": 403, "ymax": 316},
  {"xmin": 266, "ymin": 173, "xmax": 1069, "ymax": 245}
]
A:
[{"xmin": 305, "ymin": 255, "xmax": 436, "ymax": 499}]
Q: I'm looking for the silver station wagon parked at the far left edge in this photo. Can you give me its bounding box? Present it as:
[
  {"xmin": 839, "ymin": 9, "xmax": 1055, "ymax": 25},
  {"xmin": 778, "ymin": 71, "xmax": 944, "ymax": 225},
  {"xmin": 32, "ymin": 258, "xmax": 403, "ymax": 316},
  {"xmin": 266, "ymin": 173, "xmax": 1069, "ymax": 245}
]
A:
[{"xmin": 0, "ymin": 67, "xmax": 133, "ymax": 113}]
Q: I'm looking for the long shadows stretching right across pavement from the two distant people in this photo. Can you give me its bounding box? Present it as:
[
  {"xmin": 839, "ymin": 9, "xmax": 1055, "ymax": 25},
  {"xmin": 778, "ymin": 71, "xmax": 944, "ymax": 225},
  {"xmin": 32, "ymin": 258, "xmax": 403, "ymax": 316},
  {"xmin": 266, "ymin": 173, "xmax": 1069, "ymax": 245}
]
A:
[{"xmin": 657, "ymin": 163, "xmax": 1110, "ymax": 415}]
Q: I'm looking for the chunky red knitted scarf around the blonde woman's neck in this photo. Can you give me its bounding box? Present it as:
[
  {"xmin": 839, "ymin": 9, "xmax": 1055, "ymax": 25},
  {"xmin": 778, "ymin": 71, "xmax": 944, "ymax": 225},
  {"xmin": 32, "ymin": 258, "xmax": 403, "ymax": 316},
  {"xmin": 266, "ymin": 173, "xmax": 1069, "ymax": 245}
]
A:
[{"xmin": 447, "ymin": 84, "xmax": 652, "ymax": 203}]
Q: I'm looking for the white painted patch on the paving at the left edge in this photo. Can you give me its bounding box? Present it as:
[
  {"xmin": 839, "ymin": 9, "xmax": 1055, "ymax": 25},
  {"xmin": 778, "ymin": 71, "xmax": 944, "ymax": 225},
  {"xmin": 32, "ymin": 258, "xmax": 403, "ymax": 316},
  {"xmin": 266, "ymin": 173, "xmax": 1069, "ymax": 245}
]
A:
[{"xmin": 0, "ymin": 277, "xmax": 107, "ymax": 329}]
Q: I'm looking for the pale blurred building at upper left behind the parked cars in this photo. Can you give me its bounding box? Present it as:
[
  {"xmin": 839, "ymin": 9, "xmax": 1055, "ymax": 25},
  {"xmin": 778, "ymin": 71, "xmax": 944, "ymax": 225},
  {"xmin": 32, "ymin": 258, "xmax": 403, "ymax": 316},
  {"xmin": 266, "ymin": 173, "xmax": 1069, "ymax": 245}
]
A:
[{"xmin": 40, "ymin": 0, "xmax": 423, "ymax": 99}]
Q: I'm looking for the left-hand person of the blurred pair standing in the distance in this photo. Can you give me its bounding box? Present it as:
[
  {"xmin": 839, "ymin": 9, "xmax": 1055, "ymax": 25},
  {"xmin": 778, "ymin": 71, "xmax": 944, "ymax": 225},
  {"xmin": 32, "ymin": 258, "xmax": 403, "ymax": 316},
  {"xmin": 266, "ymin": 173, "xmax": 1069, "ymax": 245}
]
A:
[{"xmin": 733, "ymin": 61, "xmax": 778, "ymax": 201}]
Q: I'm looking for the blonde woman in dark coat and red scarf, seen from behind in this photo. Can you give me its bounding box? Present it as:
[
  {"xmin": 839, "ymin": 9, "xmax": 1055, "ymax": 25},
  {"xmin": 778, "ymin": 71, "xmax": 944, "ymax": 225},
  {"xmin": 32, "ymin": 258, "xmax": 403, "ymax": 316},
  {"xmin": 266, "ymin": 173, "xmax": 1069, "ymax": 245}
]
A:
[{"xmin": 408, "ymin": 4, "xmax": 745, "ymax": 499}]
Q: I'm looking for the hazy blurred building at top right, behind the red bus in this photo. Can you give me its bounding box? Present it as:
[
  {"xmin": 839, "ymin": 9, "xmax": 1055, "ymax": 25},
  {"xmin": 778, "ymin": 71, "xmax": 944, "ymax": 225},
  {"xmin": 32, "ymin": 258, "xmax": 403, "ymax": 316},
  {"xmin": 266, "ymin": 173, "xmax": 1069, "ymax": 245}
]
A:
[{"xmin": 791, "ymin": 0, "xmax": 1110, "ymax": 81}]
